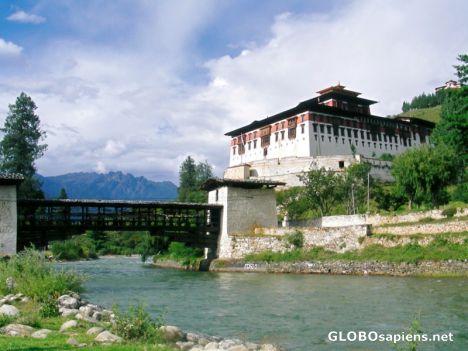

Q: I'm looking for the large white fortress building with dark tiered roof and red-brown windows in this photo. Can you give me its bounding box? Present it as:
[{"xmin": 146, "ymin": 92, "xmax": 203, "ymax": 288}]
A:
[{"xmin": 224, "ymin": 85, "xmax": 434, "ymax": 185}]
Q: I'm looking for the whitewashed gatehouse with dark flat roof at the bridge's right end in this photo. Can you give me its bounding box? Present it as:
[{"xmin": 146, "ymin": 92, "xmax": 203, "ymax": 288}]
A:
[{"xmin": 203, "ymin": 179, "xmax": 285, "ymax": 258}]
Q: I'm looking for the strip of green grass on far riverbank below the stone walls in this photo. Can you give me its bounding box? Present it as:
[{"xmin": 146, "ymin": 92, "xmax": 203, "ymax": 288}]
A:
[{"xmin": 245, "ymin": 235, "xmax": 468, "ymax": 263}]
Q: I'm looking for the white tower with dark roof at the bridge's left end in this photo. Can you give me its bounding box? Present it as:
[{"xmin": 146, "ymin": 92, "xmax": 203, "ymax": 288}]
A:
[{"xmin": 0, "ymin": 173, "xmax": 23, "ymax": 256}]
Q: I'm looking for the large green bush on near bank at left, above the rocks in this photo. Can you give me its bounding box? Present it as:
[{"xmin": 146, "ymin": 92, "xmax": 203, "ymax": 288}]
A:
[{"xmin": 0, "ymin": 248, "xmax": 84, "ymax": 302}]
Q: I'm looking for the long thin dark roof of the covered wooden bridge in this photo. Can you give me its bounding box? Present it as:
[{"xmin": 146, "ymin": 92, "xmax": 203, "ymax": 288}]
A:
[{"xmin": 18, "ymin": 199, "xmax": 222, "ymax": 209}]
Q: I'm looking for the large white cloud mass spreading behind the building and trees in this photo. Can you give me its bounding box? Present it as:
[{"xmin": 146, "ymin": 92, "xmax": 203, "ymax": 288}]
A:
[{"xmin": 0, "ymin": 0, "xmax": 468, "ymax": 186}]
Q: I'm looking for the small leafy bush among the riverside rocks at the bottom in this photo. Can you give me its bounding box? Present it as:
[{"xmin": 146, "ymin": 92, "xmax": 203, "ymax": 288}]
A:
[{"xmin": 112, "ymin": 304, "xmax": 163, "ymax": 342}]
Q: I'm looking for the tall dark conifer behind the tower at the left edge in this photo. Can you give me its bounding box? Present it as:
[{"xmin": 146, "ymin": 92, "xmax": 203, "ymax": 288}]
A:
[{"xmin": 0, "ymin": 93, "xmax": 47, "ymax": 198}]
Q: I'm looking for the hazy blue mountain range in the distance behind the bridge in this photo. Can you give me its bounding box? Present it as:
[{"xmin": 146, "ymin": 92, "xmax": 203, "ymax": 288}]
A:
[{"xmin": 38, "ymin": 172, "xmax": 177, "ymax": 201}]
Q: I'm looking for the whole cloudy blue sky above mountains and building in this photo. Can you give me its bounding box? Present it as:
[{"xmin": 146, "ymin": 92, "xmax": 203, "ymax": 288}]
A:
[{"xmin": 0, "ymin": 0, "xmax": 468, "ymax": 183}]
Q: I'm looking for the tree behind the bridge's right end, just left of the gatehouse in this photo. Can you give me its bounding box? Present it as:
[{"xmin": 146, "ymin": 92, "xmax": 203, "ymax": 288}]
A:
[{"xmin": 178, "ymin": 156, "xmax": 213, "ymax": 202}]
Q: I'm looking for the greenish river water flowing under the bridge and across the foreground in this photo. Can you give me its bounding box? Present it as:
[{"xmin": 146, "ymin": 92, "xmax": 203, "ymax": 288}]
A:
[{"xmin": 60, "ymin": 257, "xmax": 468, "ymax": 351}]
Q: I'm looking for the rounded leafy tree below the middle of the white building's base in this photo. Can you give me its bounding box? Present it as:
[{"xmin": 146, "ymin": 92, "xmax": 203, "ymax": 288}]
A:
[{"xmin": 299, "ymin": 167, "xmax": 344, "ymax": 216}]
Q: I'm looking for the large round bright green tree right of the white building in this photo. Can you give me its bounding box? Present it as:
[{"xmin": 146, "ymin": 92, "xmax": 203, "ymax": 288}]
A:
[{"xmin": 392, "ymin": 145, "xmax": 460, "ymax": 208}]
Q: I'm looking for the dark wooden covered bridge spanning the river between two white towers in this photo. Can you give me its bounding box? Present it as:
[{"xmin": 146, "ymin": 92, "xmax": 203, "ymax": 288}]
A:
[{"xmin": 17, "ymin": 200, "xmax": 222, "ymax": 253}]
